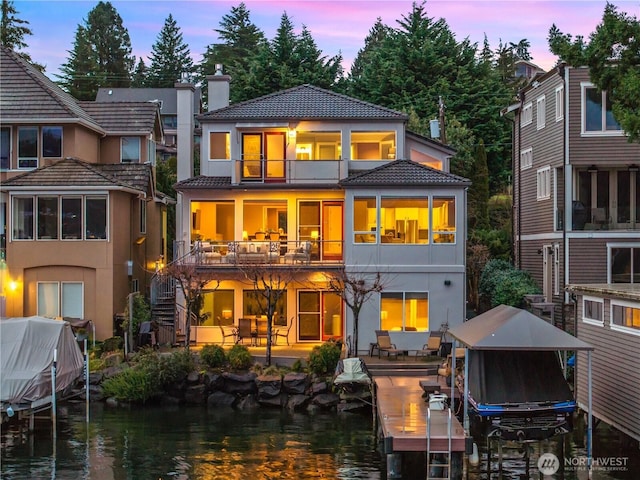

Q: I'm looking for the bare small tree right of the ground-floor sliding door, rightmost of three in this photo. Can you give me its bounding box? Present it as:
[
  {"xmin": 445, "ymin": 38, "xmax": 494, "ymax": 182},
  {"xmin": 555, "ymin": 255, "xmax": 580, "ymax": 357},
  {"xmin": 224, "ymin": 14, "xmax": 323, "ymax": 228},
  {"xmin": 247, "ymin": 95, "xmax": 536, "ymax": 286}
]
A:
[{"xmin": 327, "ymin": 269, "xmax": 384, "ymax": 356}]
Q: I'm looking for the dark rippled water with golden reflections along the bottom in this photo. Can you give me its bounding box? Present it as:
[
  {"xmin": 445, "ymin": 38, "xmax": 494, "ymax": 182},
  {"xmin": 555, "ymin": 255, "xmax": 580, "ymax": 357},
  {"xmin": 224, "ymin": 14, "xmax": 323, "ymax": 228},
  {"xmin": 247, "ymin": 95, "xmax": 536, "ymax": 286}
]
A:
[{"xmin": 0, "ymin": 404, "xmax": 640, "ymax": 480}]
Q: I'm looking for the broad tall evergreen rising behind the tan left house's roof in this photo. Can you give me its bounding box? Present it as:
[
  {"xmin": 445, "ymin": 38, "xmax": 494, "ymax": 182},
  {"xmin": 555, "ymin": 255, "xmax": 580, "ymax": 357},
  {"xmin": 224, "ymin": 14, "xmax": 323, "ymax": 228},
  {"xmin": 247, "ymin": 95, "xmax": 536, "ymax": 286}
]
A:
[{"xmin": 60, "ymin": 2, "xmax": 135, "ymax": 100}]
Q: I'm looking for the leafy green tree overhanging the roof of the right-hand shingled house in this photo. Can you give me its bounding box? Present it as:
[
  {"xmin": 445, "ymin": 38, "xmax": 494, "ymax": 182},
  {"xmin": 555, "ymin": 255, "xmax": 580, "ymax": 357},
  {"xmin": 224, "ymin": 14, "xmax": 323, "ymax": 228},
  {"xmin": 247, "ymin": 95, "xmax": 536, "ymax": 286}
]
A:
[{"xmin": 549, "ymin": 3, "xmax": 640, "ymax": 142}]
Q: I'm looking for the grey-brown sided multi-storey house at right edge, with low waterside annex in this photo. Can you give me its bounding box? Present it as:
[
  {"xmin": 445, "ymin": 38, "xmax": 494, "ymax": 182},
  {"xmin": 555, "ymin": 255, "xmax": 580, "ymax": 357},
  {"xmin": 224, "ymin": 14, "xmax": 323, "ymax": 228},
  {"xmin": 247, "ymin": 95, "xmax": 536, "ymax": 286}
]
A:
[{"xmin": 507, "ymin": 65, "xmax": 640, "ymax": 442}]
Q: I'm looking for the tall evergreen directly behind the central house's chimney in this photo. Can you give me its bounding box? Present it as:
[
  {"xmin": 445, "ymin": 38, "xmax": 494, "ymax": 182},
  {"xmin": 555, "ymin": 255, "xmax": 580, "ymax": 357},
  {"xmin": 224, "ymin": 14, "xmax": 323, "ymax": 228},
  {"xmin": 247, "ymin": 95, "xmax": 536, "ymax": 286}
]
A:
[{"xmin": 198, "ymin": 3, "xmax": 267, "ymax": 102}]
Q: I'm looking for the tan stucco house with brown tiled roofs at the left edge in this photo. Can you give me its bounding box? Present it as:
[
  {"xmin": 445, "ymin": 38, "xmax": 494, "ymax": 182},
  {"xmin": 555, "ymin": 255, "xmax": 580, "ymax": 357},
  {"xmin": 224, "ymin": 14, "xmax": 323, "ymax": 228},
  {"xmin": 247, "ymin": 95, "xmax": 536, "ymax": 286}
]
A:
[{"xmin": 0, "ymin": 47, "xmax": 169, "ymax": 339}]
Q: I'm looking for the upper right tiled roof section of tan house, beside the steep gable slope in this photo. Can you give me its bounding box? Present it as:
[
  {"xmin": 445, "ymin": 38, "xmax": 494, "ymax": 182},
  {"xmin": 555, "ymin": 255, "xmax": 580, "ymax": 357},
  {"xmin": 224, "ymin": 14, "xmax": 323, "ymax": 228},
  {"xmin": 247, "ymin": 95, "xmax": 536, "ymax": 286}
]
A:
[{"xmin": 79, "ymin": 102, "xmax": 158, "ymax": 135}]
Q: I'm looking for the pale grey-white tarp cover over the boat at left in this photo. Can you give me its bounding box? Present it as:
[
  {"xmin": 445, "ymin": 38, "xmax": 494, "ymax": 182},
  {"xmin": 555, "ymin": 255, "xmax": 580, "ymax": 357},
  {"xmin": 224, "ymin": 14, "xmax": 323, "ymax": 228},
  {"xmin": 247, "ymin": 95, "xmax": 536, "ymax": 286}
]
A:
[{"xmin": 0, "ymin": 317, "xmax": 84, "ymax": 404}]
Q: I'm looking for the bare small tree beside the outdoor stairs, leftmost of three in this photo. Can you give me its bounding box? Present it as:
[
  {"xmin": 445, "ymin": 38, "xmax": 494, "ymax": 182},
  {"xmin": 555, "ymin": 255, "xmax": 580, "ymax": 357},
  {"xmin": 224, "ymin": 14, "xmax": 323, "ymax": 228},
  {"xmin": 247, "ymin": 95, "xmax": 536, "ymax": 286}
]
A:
[{"xmin": 165, "ymin": 262, "xmax": 220, "ymax": 350}]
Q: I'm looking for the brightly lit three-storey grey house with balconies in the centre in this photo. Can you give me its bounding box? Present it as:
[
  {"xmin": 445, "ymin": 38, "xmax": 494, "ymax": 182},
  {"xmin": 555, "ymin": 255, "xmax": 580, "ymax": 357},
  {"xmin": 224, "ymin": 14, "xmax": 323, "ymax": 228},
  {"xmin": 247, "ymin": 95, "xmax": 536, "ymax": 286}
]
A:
[{"xmin": 170, "ymin": 72, "xmax": 470, "ymax": 353}]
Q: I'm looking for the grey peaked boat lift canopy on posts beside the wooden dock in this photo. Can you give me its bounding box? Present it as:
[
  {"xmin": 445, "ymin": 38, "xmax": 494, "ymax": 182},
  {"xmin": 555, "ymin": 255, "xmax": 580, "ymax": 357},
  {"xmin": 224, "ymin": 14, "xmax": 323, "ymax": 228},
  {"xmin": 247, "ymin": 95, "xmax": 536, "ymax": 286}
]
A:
[{"xmin": 447, "ymin": 305, "xmax": 594, "ymax": 466}]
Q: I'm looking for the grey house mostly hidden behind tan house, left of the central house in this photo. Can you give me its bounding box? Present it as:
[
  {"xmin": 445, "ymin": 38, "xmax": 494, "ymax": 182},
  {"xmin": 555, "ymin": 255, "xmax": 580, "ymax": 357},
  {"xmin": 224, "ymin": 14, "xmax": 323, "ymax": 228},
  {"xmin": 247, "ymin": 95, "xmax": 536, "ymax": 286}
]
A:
[{"xmin": 96, "ymin": 88, "xmax": 202, "ymax": 160}]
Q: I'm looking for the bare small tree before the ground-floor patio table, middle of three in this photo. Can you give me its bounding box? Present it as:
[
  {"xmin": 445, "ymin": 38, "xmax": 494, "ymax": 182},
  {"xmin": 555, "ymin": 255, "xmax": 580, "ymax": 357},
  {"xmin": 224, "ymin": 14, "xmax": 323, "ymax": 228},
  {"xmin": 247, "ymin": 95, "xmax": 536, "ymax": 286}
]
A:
[{"xmin": 238, "ymin": 262, "xmax": 299, "ymax": 366}]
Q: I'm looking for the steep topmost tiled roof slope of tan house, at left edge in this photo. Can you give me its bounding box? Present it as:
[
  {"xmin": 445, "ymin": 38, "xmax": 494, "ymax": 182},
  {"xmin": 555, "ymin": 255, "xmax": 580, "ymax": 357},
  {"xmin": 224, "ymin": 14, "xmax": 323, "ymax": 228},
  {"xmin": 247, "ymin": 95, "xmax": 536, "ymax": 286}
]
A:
[{"xmin": 0, "ymin": 45, "xmax": 102, "ymax": 132}]
